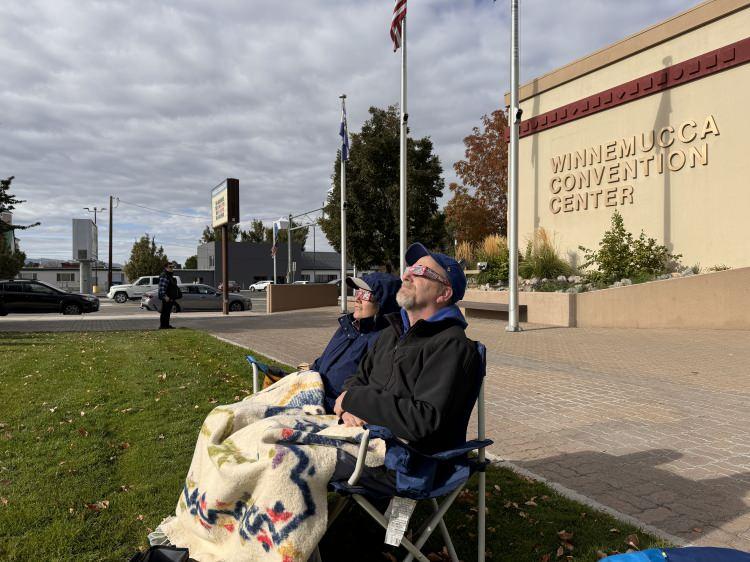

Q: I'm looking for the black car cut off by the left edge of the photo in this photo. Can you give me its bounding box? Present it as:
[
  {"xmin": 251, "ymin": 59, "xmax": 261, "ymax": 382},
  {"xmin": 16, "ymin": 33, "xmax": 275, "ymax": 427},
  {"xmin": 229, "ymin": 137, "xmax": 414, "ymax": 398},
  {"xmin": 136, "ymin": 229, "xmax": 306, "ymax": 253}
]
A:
[{"xmin": 0, "ymin": 279, "xmax": 99, "ymax": 316}]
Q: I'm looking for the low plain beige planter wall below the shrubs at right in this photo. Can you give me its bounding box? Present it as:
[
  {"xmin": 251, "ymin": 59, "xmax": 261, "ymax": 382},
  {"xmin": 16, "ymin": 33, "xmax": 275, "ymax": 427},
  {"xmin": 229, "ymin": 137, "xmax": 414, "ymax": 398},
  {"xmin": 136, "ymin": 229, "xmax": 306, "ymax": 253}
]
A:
[{"xmin": 576, "ymin": 267, "xmax": 750, "ymax": 330}]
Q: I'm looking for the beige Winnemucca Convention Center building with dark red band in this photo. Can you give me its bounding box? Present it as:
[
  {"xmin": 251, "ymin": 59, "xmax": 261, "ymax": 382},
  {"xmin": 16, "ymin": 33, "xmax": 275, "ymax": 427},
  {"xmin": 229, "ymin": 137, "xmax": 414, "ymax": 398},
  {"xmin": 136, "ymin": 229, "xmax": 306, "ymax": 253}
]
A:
[{"xmin": 506, "ymin": 0, "xmax": 750, "ymax": 268}]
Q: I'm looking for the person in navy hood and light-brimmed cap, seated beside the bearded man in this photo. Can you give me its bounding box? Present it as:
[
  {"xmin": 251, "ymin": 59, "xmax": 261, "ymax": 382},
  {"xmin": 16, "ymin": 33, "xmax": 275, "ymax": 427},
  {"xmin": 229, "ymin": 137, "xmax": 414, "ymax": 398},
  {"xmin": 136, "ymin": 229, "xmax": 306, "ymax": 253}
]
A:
[{"xmin": 310, "ymin": 273, "xmax": 401, "ymax": 413}]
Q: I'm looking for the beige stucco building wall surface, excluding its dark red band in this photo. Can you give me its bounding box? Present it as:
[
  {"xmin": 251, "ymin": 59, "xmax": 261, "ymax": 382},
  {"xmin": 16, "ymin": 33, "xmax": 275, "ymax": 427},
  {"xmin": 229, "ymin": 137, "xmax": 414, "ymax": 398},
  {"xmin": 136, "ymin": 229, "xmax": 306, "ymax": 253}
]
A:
[{"xmin": 519, "ymin": 8, "xmax": 750, "ymax": 267}]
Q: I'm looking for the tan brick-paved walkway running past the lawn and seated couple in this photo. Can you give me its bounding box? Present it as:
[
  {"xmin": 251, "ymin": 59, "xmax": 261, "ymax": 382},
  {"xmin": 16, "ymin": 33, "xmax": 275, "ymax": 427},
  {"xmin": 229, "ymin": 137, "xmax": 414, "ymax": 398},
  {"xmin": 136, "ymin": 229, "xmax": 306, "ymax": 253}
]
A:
[{"xmin": 210, "ymin": 308, "xmax": 750, "ymax": 550}]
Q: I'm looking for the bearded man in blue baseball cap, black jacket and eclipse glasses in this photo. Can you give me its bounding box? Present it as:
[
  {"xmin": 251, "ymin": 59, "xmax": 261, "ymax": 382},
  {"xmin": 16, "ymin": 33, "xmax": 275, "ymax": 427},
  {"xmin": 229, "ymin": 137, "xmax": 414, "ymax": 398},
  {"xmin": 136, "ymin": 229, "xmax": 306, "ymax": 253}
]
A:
[{"xmin": 334, "ymin": 243, "xmax": 480, "ymax": 456}]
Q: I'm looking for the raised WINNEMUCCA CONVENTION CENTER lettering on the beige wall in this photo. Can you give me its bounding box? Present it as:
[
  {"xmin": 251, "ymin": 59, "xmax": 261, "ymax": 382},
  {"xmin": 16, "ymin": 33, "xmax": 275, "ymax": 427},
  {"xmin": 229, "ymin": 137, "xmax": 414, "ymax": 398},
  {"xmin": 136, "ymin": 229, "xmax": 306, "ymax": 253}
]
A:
[{"xmin": 549, "ymin": 115, "xmax": 719, "ymax": 214}]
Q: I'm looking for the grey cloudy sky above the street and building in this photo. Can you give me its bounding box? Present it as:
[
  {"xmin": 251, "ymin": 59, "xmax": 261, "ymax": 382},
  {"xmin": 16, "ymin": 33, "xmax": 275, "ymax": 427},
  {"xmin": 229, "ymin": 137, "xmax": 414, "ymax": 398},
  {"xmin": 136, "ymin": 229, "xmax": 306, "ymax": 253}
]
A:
[{"xmin": 0, "ymin": 0, "xmax": 697, "ymax": 262}]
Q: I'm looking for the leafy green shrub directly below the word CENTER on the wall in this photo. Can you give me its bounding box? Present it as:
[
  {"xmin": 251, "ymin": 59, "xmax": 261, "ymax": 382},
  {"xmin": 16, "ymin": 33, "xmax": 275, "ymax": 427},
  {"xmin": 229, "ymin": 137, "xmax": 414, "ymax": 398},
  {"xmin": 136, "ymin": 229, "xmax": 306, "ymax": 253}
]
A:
[{"xmin": 579, "ymin": 211, "xmax": 682, "ymax": 283}]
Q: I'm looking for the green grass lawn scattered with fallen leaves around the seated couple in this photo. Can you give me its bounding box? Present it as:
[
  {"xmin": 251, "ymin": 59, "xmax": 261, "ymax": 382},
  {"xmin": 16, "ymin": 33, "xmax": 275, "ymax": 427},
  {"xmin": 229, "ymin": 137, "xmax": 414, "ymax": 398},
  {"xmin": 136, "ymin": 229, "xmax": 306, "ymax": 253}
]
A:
[{"xmin": 0, "ymin": 330, "xmax": 659, "ymax": 562}]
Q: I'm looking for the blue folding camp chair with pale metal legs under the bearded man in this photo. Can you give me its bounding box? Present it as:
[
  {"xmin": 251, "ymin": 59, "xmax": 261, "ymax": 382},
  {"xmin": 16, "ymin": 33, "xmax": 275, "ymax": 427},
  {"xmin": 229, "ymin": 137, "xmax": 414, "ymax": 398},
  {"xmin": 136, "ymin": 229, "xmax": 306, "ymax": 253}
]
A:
[{"xmin": 318, "ymin": 342, "xmax": 492, "ymax": 562}]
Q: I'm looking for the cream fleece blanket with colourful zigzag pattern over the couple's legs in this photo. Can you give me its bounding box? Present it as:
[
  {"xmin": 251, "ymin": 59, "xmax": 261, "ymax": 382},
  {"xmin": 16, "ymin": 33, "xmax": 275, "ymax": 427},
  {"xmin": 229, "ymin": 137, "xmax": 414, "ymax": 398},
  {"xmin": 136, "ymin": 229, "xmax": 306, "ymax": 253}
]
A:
[{"xmin": 160, "ymin": 371, "xmax": 385, "ymax": 562}]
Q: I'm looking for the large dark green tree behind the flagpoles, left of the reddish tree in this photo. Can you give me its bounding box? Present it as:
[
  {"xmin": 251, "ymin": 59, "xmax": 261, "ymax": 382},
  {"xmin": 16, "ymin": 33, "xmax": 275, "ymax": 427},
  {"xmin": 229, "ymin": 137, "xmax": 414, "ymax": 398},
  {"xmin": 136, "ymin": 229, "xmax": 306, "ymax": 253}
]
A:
[{"xmin": 320, "ymin": 106, "xmax": 448, "ymax": 271}]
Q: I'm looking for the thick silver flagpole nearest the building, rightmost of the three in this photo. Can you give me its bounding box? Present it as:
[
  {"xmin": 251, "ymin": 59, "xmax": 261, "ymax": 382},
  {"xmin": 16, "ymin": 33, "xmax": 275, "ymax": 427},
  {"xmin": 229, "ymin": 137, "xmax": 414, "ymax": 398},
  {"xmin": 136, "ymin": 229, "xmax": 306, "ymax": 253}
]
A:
[{"xmin": 505, "ymin": 0, "xmax": 521, "ymax": 332}]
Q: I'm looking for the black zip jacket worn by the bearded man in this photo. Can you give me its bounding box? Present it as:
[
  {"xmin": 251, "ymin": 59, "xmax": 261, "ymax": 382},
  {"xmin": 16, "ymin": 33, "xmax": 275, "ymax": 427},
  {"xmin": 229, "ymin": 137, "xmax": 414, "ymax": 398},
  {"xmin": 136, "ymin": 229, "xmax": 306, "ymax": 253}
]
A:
[{"xmin": 342, "ymin": 305, "xmax": 480, "ymax": 454}]
